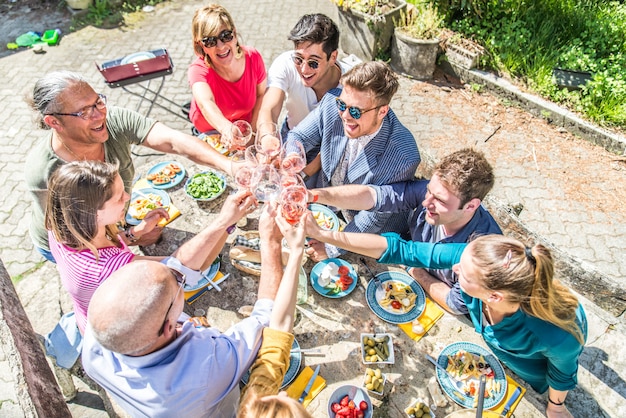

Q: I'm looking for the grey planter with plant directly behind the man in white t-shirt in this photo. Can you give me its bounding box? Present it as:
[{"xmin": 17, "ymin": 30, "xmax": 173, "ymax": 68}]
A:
[{"xmin": 333, "ymin": 0, "xmax": 406, "ymax": 61}]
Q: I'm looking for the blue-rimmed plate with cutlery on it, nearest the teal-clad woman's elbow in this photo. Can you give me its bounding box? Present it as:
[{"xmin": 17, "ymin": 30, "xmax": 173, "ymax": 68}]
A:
[{"xmin": 435, "ymin": 341, "xmax": 507, "ymax": 409}]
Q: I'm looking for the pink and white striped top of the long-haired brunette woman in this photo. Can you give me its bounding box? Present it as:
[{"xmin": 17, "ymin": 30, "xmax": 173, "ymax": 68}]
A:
[{"xmin": 48, "ymin": 231, "xmax": 135, "ymax": 333}]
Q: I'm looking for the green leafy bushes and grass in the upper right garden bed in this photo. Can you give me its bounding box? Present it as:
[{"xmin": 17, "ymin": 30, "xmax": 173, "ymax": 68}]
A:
[{"xmin": 424, "ymin": 0, "xmax": 626, "ymax": 128}]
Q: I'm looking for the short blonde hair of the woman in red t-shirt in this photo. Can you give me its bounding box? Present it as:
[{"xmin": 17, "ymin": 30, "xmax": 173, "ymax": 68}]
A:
[{"xmin": 191, "ymin": 4, "xmax": 243, "ymax": 67}]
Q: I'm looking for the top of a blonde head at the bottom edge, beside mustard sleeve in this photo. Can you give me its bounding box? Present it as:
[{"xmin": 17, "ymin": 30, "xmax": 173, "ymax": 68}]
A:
[{"xmin": 237, "ymin": 392, "xmax": 311, "ymax": 418}]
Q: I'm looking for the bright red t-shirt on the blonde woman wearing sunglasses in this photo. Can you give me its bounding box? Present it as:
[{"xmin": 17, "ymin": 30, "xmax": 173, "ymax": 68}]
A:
[{"xmin": 187, "ymin": 46, "xmax": 267, "ymax": 132}]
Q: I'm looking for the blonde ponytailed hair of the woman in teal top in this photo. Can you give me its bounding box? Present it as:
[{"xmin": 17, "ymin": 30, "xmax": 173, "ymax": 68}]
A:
[{"xmin": 470, "ymin": 235, "xmax": 585, "ymax": 344}]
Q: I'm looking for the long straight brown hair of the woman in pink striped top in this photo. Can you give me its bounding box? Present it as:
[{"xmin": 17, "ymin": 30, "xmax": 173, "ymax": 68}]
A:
[{"xmin": 45, "ymin": 161, "xmax": 120, "ymax": 260}]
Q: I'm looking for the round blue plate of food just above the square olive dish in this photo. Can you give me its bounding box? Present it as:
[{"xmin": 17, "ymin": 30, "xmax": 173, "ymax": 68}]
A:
[{"xmin": 365, "ymin": 271, "xmax": 426, "ymax": 324}]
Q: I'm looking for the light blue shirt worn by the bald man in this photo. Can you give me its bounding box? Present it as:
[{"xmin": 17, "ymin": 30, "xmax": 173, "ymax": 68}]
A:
[{"xmin": 82, "ymin": 299, "xmax": 274, "ymax": 418}]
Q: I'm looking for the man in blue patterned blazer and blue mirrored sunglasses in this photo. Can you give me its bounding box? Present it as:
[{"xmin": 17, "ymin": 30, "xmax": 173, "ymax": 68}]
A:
[{"xmin": 287, "ymin": 61, "xmax": 420, "ymax": 261}]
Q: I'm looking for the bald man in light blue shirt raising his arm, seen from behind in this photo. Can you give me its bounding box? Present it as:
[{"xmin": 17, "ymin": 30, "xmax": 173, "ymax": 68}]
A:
[{"xmin": 82, "ymin": 208, "xmax": 286, "ymax": 417}]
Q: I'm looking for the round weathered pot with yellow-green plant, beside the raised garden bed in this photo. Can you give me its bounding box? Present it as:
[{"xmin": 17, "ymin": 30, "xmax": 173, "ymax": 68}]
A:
[{"xmin": 391, "ymin": 3, "xmax": 443, "ymax": 80}]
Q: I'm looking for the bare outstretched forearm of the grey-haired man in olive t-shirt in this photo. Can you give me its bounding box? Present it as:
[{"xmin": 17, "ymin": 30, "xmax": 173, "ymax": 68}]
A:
[{"xmin": 142, "ymin": 122, "xmax": 232, "ymax": 174}]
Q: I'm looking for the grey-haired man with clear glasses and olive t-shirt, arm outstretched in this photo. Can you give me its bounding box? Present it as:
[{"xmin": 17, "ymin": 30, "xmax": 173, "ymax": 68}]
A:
[{"xmin": 25, "ymin": 71, "xmax": 231, "ymax": 261}]
